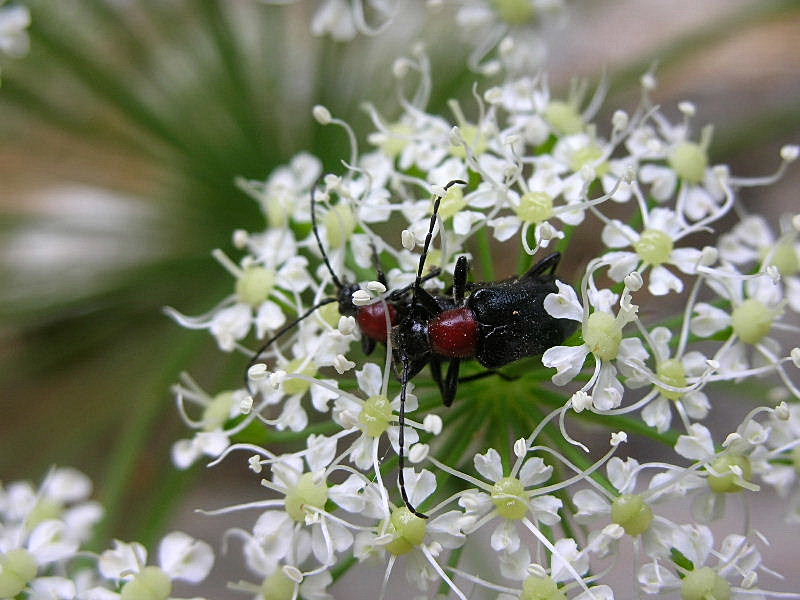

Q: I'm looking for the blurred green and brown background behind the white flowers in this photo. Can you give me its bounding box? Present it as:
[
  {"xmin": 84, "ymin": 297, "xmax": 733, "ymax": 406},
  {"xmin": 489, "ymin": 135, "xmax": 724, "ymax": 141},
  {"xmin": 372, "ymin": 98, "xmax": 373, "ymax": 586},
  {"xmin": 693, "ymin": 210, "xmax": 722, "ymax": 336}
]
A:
[{"xmin": 0, "ymin": 0, "xmax": 800, "ymax": 598}]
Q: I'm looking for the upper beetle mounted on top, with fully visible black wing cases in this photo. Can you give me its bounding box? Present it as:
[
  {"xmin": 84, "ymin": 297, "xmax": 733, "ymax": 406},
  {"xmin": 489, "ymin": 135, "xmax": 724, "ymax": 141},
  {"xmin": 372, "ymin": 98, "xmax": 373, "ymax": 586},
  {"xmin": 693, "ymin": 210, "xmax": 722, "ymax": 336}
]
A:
[{"xmin": 391, "ymin": 181, "xmax": 577, "ymax": 518}]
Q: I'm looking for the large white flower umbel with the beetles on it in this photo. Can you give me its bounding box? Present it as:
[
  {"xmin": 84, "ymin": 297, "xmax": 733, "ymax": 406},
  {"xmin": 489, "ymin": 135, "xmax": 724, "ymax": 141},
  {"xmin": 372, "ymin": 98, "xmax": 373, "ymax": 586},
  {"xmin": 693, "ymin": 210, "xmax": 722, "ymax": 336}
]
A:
[{"xmin": 168, "ymin": 49, "xmax": 800, "ymax": 600}]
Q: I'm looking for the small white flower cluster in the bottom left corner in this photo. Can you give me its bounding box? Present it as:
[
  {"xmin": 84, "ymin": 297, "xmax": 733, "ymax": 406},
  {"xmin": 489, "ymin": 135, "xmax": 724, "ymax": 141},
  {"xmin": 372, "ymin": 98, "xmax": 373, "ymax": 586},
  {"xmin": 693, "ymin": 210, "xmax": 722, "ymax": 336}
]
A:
[{"xmin": 0, "ymin": 468, "xmax": 214, "ymax": 600}]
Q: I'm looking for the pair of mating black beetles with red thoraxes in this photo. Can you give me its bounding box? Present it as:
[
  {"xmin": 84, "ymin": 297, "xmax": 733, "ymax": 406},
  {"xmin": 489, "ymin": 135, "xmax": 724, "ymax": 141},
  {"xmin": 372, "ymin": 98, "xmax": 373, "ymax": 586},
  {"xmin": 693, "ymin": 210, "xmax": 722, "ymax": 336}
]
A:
[{"xmin": 248, "ymin": 179, "xmax": 577, "ymax": 518}]
